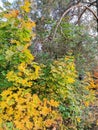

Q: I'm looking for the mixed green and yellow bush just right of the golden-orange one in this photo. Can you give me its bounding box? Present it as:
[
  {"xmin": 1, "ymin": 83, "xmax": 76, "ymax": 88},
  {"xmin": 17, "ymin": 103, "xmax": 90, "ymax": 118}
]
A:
[{"xmin": 32, "ymin": 56, "xmax": 95, "ymax": 130}]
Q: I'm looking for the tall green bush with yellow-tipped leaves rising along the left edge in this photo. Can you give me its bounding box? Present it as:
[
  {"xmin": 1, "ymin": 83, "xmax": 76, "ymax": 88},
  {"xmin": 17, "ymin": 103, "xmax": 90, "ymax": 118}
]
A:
[{"xmin": 0, "ymin": 1, "xmax": 39, "ymax": 91}]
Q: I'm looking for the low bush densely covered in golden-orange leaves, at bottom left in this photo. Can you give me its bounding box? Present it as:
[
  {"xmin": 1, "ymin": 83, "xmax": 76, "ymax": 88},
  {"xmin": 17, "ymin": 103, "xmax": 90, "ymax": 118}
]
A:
[{"xmin": 0, "ymin": 87, "xmax": 62, "ymax": 130}]
